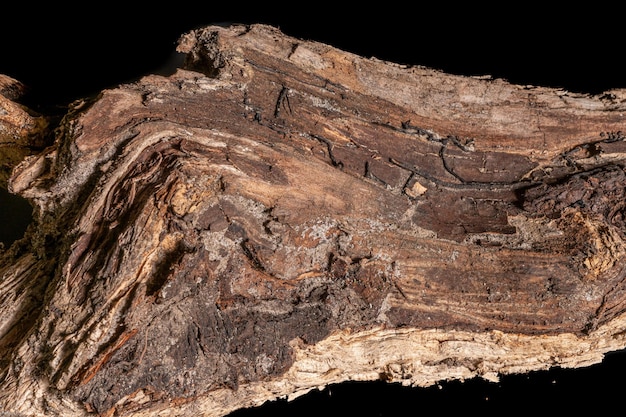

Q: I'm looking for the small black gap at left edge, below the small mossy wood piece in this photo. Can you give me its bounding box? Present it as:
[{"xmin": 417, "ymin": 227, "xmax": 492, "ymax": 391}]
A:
[{"xmin": 0, "ymin": 187, "xmax": 33, "ymax": 248}]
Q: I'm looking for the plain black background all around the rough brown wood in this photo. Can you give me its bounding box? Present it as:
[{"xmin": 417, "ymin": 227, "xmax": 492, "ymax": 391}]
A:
[{"xmin": 0, "ymin": 1, "xmax": 626, "ymax": 417}]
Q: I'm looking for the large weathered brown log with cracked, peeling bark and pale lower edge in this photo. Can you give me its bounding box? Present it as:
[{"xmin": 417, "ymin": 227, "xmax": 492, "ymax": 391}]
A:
[{"xmin": 0, "ymin": 26, "xmax": 626, "ymax": 416}]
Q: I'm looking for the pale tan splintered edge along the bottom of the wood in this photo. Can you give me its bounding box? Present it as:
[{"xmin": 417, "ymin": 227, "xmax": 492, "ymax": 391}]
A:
[{"xmin": 26, "ymin": 315, "xmax": 626, "ymax": 417}]
